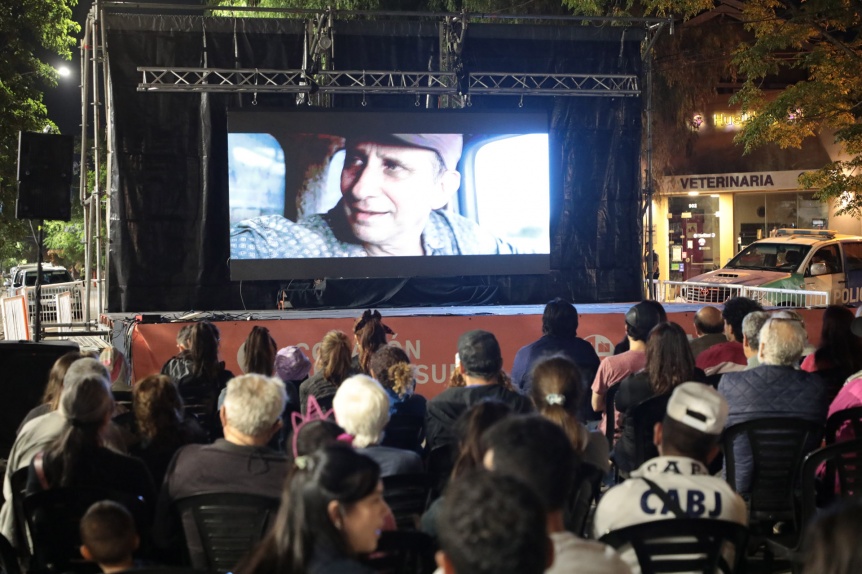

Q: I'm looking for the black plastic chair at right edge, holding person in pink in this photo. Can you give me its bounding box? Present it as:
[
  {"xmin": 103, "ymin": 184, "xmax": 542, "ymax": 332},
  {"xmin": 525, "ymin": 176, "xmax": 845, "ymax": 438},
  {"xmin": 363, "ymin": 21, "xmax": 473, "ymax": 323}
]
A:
[{"xmin": 766, "ymin": 438, "xmax": 862, "ymax": 572}]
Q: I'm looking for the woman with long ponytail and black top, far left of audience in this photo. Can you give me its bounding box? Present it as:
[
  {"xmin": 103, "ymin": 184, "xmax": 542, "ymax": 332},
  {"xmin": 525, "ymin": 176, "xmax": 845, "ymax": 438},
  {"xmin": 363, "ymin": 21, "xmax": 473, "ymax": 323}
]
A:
[{"xmin": 27, "ymin": 359, "xmax": 155, "ymax": 504}]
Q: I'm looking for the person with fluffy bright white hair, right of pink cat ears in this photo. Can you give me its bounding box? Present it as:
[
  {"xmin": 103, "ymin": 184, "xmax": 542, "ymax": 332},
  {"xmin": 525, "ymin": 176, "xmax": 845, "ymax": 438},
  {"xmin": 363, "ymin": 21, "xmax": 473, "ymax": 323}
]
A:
[{"xmin": 332, "ymin": 375, "xmax": 423, "ymax": 477}]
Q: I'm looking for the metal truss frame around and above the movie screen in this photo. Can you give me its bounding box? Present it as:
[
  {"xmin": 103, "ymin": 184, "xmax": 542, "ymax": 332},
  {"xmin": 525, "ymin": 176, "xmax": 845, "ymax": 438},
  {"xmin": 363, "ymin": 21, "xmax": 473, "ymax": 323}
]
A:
[{"xmin": 80, "ymin": 0, "xmax": 673, "ymax": 322}]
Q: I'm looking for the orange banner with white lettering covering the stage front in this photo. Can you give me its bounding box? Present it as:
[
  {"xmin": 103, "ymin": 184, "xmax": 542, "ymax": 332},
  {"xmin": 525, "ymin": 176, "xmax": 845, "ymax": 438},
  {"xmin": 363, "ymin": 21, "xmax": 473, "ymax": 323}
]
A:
[{"xmin": 132, "ymin": 306, "xmax": 823, "ymax": 398}]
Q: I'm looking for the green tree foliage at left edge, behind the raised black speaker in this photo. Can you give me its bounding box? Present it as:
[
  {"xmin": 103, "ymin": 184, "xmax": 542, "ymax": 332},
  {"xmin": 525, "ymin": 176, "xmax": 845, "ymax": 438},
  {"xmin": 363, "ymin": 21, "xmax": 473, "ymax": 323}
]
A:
[{"xmin": 0, "ymin": 0, "xmax": 79, "ymax": 267}]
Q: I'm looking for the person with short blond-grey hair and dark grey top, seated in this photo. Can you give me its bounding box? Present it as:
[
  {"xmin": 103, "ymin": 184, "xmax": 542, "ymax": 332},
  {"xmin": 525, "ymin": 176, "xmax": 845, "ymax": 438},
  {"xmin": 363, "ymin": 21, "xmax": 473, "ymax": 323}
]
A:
[{"xmin": 153, "ymin": 375, "xmax": 288, "ymax": 564}]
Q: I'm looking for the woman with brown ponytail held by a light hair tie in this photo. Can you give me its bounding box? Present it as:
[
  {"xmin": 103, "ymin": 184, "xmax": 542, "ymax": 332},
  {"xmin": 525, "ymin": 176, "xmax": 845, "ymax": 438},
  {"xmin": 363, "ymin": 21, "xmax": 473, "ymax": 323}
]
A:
[{"xmin": 530, "ymin": 355, "xmax": 610, "ymax": 472}]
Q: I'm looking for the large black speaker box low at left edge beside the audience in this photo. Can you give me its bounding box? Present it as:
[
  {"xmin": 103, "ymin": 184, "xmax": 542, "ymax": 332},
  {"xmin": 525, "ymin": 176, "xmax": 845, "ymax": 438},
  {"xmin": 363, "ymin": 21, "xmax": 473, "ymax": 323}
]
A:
[{"xmin": 0, "ymin": 341, "xmax": 79, "ymax": 458}]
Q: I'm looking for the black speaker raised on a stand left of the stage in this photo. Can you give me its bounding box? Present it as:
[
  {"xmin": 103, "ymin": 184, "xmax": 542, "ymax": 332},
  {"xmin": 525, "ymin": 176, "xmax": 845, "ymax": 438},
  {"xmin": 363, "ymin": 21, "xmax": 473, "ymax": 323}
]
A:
[{"xmin": 15, "ymin": 132, "xmax": 75, "ymax": 221}]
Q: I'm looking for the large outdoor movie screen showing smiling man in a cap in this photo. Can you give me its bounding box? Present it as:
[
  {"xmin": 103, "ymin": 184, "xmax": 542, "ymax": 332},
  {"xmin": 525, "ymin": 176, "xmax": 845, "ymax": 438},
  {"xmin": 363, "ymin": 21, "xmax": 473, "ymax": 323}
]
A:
[{"xmin": 228, "ymin": 110, "xmax": 551, "ymax": 280}]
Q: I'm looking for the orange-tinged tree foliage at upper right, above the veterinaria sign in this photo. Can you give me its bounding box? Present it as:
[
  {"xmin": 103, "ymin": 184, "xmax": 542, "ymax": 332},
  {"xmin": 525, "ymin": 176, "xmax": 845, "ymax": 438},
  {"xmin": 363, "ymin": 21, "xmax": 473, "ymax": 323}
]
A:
[{"xmin": 734, "ymin": 0, "xmax": 862, "ymax": 216}]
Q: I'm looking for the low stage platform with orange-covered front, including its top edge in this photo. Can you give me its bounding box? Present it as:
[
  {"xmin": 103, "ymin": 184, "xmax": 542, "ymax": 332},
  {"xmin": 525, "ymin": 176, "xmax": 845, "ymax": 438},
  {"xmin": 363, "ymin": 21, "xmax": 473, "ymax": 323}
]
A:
[{"xmin": 101, "ymin": 303, "xmax": 823, "ymax": 398}]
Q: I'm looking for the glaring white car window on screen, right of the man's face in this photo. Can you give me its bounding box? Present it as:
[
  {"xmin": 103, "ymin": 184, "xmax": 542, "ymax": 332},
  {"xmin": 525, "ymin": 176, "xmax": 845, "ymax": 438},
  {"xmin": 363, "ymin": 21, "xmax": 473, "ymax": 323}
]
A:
[{"xmin": 473, "ymin": 134, "xmax": 550, "ymax": 253}]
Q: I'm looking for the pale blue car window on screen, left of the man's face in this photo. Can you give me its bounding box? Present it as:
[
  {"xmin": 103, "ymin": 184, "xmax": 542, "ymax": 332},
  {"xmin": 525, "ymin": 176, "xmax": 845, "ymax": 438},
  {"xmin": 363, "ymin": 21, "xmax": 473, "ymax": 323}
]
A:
[{"xmin": 227, "ymin": 133, "xmax": 285, "ymax": 225}]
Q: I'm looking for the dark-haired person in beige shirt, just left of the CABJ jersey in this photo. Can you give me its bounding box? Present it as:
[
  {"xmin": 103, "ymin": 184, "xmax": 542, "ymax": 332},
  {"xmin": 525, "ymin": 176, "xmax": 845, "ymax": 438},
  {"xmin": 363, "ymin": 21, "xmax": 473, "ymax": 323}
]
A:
[{"xmin": 482, "ymin": 415, "xmax": 629, "ymax": 574}]
